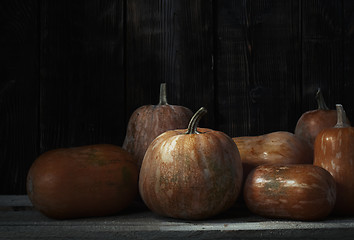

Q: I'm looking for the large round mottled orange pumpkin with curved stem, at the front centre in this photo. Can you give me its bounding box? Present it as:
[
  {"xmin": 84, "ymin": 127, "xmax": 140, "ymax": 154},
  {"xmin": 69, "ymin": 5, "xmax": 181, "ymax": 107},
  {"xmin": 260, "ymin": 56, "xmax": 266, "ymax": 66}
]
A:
[{"xmin": 139, "ymin": 108, "xmax": 242, "ymax": 219}]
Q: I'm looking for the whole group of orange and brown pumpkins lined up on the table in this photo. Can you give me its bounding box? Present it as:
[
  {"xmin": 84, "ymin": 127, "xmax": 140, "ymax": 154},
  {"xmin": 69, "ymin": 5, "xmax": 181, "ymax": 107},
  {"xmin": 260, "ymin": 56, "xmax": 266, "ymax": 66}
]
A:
[{"xmin": 27, "ymin": 84, "xmax": 354, "ymax": 220}]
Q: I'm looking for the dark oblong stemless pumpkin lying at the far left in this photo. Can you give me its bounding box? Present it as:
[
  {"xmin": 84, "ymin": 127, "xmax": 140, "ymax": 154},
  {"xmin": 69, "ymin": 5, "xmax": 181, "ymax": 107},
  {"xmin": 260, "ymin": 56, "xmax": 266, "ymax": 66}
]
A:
[{"xmin": 27, "ymin": 144, "xmax": 138, "ymax": 219}]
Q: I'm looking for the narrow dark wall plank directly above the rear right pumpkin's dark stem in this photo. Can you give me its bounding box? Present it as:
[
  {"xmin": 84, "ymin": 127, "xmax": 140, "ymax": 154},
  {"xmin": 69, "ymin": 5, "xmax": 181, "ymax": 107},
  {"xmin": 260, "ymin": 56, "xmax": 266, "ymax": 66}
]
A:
[{"xmin": 302, "ymin": 0, "xmax": 345, "ymax": 116}]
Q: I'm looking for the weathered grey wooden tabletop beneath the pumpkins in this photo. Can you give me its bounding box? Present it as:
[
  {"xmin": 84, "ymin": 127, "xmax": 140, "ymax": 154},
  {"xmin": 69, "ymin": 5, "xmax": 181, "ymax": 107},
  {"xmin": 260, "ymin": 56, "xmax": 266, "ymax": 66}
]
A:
[{"xmin": 0, "ymin": 195, "xmax": 354, "ymax": 240}]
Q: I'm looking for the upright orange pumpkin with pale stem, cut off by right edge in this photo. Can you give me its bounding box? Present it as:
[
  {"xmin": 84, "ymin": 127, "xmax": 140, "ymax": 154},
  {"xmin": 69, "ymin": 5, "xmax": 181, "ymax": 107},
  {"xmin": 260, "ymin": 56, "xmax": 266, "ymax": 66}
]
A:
[{"xmin": 314, "ymin": 104, "xmax": 354, "ymax": 215}]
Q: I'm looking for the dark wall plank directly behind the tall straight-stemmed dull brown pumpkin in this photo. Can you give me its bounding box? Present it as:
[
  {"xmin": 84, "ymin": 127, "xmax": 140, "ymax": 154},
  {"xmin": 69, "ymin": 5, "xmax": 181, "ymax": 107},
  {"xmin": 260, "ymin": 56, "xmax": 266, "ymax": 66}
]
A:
[{"xmin": 126, "ymin": 0, "xmax": 214, "ymax": 127}]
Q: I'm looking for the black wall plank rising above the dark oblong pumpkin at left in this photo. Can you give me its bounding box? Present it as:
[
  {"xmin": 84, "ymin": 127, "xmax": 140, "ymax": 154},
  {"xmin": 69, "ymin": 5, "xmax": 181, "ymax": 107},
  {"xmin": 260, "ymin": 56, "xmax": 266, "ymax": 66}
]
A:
[{"xmin": 40, "ymin": 0, "xmax": 125, "ymax": 152}]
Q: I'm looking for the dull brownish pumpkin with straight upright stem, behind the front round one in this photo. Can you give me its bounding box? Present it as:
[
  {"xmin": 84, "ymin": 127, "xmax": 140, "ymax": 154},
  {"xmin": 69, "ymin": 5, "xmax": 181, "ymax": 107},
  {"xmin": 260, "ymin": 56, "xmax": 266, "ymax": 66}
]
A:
[{"xmin": 122, "ymin": 83, "xmax": 193, "ymax": 168}]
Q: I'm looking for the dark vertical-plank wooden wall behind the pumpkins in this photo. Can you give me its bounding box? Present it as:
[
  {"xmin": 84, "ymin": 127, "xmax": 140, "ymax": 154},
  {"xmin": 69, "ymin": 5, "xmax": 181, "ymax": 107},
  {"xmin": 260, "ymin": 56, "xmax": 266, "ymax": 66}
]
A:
[{"xmin": 0, "ymin": 0, "xmax": 354, "ymax": 194}]
